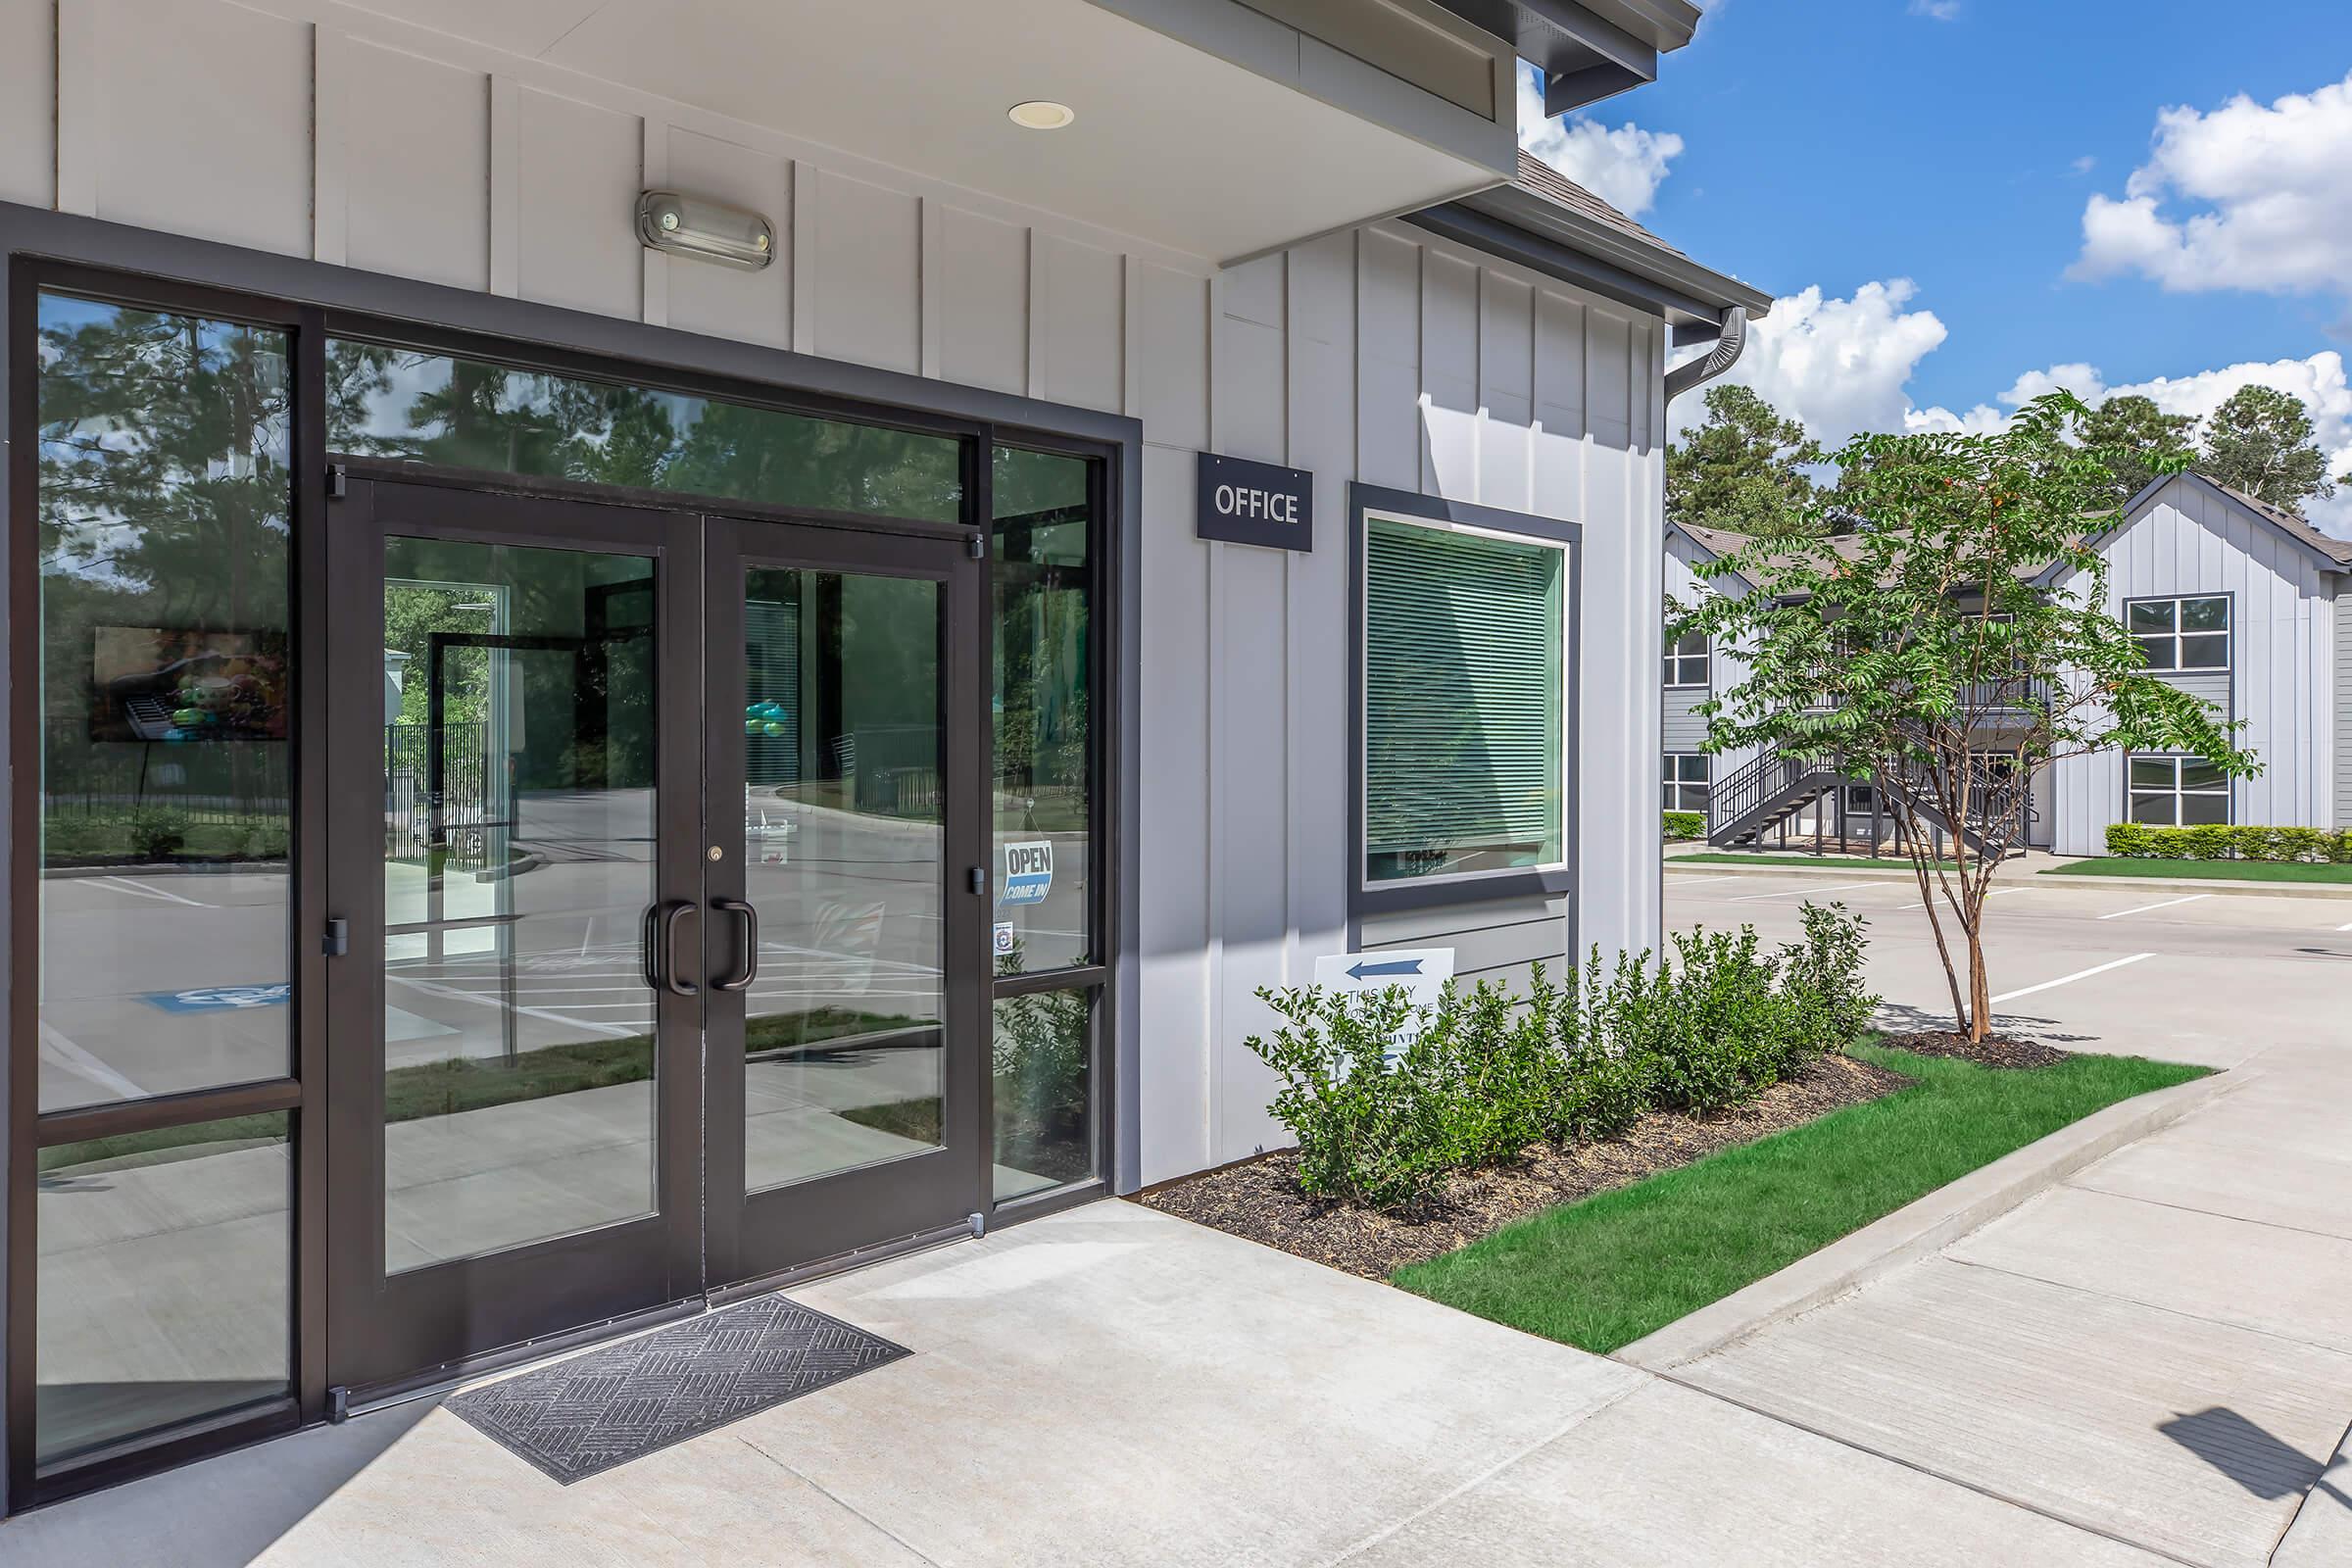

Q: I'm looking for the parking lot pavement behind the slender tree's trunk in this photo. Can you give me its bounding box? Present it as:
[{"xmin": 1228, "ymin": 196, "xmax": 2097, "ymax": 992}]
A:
[{"xmin": 1665, "ymin": 872, "xmax": 2352, "ymax": 1067}]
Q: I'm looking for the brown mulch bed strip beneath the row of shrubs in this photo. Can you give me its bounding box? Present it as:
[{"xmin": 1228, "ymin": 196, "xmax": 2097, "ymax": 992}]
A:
[{"xmin": 1136, "ymin": 1055, "xmax": 1910, "ymax": 1279}]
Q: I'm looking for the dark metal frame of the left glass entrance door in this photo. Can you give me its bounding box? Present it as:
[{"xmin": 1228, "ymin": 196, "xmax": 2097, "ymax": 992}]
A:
[{"xmin": 327, "ymin": 467, "xmax": 704, "ymax": 1403}]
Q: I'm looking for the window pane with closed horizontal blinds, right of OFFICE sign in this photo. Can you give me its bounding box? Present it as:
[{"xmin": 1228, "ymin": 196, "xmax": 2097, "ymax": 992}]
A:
[{"xmin": 1364, "ymin": 517, "xmax": 1566, "ymax": 884}]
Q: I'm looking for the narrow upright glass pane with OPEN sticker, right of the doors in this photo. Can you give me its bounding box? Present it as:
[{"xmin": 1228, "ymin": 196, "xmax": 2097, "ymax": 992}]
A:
[{"xmin": 990, "ymin": 447, "xmax": 1096, "ymax": 976}]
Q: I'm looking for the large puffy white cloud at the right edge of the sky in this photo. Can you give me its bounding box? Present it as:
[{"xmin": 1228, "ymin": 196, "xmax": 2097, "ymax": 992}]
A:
[{"xmin": 2070, "ymin": 73, "xmax": 2352, "ymax": 294}]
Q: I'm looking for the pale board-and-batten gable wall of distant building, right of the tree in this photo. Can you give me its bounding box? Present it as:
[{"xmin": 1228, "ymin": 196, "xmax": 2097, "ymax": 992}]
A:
[{"xmin": 2053, "ymin": 477, "xmax": 2345, "ymax": 856}]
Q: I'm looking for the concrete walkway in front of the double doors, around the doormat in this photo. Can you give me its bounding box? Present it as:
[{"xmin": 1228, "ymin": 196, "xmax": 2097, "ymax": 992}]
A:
[{"xmin": 0, "ymin": 1201, "xmax": 2164, "ymax": 1568}]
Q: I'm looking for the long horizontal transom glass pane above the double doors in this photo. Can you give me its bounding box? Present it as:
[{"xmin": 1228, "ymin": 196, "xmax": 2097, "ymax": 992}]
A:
[{"xmin": 327, "ymin": 338, "xmax": 964, "ymax": 522}]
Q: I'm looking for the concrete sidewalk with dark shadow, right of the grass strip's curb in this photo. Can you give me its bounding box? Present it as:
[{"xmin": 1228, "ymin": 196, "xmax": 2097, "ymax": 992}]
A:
[{"xmin": 1660, "ymin": 1046, "xmax": 2352, "ymax": 1568}]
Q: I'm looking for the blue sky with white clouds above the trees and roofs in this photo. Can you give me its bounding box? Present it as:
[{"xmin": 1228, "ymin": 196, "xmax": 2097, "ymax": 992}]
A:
[{"xmin": 1522, "ymin": 0, "xmax": 2352, "ymax": 531}]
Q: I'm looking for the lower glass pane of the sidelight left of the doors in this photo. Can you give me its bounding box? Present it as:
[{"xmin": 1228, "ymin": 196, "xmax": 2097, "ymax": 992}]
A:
[{"xmin": 33, "ymin": 1114, "xmax": 294, "ymax": 1469}]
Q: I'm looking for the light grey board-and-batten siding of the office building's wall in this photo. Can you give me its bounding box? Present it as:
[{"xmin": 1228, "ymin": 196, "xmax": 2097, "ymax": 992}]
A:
[{"xmin": 0, "ymin": 0, "xmax": 1665, "ymax": 1180}]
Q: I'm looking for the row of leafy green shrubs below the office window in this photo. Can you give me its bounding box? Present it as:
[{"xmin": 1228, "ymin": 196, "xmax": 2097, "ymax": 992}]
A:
[{"xmin": 1249, "ymin": 906, "xmax": 1877, "ymax": 1208}]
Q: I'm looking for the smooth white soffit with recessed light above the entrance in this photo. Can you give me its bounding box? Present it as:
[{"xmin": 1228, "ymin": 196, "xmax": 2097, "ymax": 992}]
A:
[{"xmin": 343, "ymin": 0, "xmax": 1507, "ymax": 261}]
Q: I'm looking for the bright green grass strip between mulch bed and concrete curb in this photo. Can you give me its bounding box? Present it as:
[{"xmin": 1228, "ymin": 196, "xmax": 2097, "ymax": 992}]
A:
[{"xmin": 1395, "ymin": 1046, "xmax": 2206, "ymax": 1354}]
